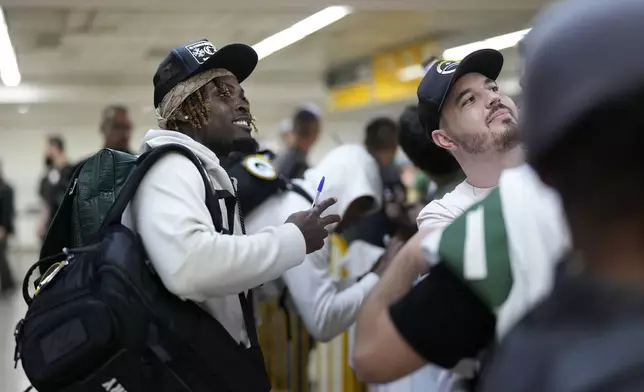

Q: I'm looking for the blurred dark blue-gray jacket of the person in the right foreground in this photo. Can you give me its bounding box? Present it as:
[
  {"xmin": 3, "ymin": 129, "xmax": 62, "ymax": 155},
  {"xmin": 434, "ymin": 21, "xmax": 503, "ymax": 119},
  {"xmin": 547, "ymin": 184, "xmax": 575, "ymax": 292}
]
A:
[{"xmin": 482, "ymin": 260, "xmax": 644, "ymax": 392}]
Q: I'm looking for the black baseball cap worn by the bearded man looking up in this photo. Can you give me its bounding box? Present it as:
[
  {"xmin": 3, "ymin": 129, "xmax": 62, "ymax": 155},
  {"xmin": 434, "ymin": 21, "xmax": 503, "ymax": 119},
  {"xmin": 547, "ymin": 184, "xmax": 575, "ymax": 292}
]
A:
[{"xmin": 418, "ymin": 49, "xmax": 503, "ymax": 132}]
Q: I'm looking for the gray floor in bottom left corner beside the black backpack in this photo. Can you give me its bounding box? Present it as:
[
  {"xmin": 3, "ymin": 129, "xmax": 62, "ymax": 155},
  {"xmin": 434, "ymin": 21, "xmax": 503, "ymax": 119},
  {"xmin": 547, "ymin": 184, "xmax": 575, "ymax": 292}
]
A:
[{"xmin": 0, "ymin": 252, "xmax": 38, "ymax": 392}]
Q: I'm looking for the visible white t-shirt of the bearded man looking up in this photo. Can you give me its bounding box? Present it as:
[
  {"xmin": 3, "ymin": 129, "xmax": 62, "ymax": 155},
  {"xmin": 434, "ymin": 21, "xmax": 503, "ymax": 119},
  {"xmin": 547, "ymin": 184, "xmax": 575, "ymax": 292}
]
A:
[{"xmin": 416, "ymin": 180, "xmax": 494, "ymax": 229}]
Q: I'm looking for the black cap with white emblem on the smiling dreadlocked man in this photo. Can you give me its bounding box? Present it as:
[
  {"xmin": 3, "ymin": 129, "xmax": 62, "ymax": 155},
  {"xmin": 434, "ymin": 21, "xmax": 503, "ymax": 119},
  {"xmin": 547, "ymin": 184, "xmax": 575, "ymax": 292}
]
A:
[{"xmin": 152, "ymin": 39, "xmax": 259, "ymax": 107}]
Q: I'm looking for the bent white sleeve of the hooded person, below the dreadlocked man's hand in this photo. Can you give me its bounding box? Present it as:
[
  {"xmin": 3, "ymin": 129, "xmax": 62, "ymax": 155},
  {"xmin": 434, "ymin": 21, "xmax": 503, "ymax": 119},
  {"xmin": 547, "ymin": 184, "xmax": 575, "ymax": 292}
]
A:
[{"xmin": 282, "ymin": 239, "xmax": 378, "ymax": 342}]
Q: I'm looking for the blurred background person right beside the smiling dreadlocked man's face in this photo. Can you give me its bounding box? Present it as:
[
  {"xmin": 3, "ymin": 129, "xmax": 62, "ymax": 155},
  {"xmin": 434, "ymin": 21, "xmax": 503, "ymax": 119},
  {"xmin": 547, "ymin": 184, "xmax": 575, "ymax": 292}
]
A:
[{"xmin": 274, "ymin": 106, "xmax": 321, "ymax": 179}]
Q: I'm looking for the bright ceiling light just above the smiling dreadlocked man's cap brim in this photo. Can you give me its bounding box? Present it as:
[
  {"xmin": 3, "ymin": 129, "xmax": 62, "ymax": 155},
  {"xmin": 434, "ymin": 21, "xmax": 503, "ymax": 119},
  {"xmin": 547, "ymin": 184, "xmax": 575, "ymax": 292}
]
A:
[{"xmin": 253, "ymin": 6, "xmax": 352, "ymax": 60}]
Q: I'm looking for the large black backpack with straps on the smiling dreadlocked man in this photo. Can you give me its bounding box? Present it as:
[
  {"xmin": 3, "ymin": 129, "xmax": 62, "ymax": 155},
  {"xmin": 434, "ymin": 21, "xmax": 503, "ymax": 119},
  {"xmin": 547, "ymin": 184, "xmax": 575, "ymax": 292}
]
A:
[{"xmin": 15, "ymin": 145, "xmax": 271, "ymax": 392}]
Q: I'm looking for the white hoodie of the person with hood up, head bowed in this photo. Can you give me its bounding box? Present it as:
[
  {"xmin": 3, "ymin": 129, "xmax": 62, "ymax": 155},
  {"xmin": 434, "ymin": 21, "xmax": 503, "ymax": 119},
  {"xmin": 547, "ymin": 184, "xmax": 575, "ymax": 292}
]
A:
[{"xmin": 246, "ymin": 145, "xmax": 382, "ymax": 341}]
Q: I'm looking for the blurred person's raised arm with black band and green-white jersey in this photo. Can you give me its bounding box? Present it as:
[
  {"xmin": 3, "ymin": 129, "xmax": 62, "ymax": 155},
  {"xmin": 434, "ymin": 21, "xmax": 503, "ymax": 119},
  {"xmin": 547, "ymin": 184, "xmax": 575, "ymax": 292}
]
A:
[{"xmin": 355, "ymin": 49, "xmax": 570, "ymax": 390}]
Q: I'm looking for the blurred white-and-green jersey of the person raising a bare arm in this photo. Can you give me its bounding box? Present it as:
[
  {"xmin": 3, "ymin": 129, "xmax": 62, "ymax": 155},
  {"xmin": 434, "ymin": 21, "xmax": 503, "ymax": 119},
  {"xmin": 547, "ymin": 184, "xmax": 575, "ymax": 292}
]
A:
[{"xmin": 421, "ymin": 164, "xmax": 571, "ymax": 338}]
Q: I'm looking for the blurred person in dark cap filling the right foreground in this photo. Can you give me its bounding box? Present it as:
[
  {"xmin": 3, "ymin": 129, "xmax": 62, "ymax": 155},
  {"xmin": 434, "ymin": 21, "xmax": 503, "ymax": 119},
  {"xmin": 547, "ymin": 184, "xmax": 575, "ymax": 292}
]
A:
[{"xmin": 483, "ymin": 0, "xmax": 644, "ymax": 392}]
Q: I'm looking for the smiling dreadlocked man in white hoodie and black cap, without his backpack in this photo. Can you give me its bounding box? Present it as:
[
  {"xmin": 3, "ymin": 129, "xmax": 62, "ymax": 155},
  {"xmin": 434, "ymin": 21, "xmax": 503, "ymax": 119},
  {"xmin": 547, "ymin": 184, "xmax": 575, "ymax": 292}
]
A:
[{"xmin": 124, "ymin": 39, "xmax": 339, "ymax": 360}]
